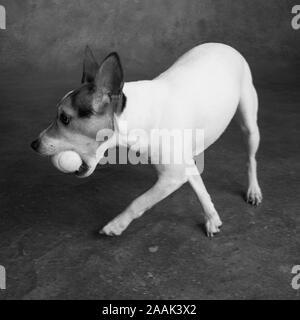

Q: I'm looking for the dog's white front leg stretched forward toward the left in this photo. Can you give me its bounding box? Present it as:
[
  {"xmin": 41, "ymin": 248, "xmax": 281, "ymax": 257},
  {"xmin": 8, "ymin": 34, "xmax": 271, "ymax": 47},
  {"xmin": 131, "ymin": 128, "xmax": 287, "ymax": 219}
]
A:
[{"xmin": 100, "ymin": 166, "xmax": 187, "ymax": 236}]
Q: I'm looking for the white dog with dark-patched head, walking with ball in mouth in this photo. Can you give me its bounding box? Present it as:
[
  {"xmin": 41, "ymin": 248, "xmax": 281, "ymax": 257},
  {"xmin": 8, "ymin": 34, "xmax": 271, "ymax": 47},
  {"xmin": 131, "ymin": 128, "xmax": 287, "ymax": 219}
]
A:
[{"xmin": 31, "ymin": 43, "xmax": 262, "ymax": 237}]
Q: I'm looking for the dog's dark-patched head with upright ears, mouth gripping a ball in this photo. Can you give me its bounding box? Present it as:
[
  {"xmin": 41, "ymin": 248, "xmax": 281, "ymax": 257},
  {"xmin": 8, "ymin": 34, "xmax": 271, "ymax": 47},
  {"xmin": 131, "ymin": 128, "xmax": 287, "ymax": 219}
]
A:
[{"xmin": 31, "ymin": 47, "xmax": 123, "ymax": 177}]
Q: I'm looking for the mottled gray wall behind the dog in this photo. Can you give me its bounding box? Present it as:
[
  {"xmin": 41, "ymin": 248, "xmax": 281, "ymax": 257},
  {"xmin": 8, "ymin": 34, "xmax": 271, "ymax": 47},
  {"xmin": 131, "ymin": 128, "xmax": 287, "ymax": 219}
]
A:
[{"xmin": 0, "ymin": 0, "xmax": 300, "ymax": 81}]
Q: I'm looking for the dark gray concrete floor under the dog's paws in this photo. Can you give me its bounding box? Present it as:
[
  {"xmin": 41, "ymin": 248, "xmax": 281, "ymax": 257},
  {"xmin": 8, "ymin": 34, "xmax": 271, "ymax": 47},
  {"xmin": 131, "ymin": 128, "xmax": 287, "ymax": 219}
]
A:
[{"xmin": 0, "ymin": 75, "xmax": 300, "ymax": 299}]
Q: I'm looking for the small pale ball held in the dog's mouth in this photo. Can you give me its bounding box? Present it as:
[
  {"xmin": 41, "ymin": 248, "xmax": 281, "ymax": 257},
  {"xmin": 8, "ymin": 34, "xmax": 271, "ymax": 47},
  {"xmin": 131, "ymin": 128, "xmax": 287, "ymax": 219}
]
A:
[{"xmin": 52, "ymin": 151, "xmax": 82, "ymax": 173}]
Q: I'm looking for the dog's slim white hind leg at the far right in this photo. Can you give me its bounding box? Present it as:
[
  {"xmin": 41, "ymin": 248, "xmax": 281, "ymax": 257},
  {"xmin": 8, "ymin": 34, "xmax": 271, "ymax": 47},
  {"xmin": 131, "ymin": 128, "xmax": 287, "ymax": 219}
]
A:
[{"xmin": 236, "ymin": 66, "xmax": 262, "ymax": 205}]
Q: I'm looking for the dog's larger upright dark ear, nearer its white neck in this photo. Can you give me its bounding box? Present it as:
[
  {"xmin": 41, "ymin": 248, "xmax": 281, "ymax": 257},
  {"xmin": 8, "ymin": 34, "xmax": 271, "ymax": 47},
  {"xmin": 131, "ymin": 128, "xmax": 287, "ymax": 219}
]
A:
[{"xmin": 95, "ymin": 52, "xmax": 124, "ymax": 97}]
